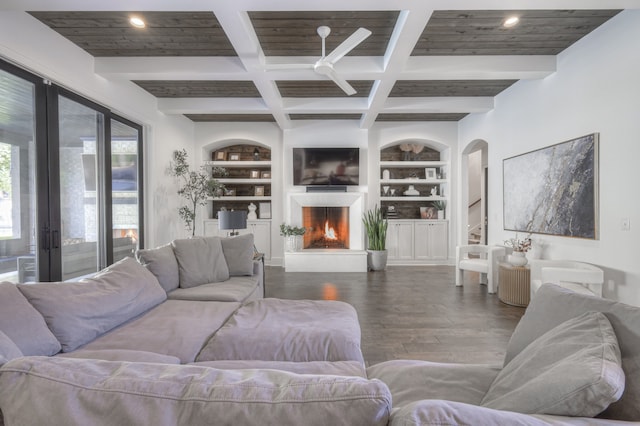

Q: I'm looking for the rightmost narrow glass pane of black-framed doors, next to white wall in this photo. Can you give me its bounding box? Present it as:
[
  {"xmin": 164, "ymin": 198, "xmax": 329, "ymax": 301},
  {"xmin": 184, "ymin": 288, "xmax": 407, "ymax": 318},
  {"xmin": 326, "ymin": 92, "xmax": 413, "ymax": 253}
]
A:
[{"xmin": 111, "ymin": 120, "xmax": 141, "ymax": 262}]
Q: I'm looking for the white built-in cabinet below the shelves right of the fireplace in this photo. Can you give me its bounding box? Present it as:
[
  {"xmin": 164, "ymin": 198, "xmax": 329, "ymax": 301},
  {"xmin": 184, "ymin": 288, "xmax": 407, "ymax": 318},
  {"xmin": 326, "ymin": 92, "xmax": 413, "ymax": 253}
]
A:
[{"xmin": 387, "ymin": 219, "xmax": 449, "ymax": 264}]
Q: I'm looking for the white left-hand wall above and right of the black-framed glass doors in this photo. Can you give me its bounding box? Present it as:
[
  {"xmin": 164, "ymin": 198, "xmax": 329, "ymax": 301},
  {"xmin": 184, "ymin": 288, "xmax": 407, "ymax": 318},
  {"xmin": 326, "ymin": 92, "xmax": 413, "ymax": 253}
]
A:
[{"xmin": 0, "ymin": 11, "xmax": 193, "ymax": 247}]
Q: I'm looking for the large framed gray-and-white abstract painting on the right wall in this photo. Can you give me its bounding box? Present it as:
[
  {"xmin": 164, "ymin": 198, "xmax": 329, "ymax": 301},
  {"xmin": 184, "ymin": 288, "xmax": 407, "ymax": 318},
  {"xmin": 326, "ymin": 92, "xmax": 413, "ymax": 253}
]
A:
[{"xmin": 502, "ymin": 133, "xmax": 599, "ymax": 239}]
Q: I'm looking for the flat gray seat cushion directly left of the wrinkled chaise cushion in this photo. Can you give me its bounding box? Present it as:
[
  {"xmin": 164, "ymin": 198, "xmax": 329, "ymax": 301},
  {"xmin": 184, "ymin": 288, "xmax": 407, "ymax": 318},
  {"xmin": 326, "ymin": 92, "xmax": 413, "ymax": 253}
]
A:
[{"xmin": 82, "ymin": 300, "xmax": 240, "ymax": 363}]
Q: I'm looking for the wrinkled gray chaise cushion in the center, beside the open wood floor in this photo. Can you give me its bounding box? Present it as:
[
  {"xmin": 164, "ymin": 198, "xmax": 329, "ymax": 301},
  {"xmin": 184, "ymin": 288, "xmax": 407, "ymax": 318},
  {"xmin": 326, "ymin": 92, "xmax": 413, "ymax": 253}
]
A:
[{"xmin": 197, "ymin": 299, "xmax": 364, "ymax": 362}]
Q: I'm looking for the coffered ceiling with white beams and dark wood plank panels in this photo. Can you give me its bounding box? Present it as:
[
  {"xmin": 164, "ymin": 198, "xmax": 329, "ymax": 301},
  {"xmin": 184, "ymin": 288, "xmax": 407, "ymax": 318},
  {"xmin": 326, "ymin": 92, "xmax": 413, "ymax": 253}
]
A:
[{"xmin": 5, "ymin": 0, "xmax": 637, "ymax": 129}]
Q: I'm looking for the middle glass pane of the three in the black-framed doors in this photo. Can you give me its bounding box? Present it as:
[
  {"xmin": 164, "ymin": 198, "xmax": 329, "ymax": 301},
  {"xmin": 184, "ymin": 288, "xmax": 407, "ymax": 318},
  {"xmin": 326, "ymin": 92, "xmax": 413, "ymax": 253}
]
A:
[{"xmin": 58, "ymin": 96, "xmax": 104, "ymax": 280}]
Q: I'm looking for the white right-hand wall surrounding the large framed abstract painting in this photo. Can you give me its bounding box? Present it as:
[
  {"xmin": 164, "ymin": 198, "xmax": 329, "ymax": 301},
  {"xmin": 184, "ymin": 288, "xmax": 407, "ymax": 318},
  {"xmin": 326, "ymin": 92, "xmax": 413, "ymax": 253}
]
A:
[{"xmin": 459, "ymin": 10, "xmax": 640, "ymax": 305}]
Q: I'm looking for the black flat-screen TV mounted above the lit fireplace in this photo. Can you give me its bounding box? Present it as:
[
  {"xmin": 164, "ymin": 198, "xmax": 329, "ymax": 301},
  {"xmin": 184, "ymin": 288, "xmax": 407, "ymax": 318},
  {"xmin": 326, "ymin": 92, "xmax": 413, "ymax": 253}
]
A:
[{"xmin": 293, "ymin": 148, "xmax": 360, "ymax": 186}]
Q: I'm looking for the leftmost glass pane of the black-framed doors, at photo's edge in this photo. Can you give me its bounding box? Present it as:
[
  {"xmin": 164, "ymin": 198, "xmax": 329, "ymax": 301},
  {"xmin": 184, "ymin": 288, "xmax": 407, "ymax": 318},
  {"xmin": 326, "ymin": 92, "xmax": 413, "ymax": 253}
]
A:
[{"xmin": 0, "ymin": 69, "xmax": 38, "ymax": 283}]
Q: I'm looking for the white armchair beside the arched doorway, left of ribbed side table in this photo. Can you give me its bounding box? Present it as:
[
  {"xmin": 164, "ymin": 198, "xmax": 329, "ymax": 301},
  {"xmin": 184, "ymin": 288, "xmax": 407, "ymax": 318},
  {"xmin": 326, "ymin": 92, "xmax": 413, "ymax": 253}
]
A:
[{"xmin": 456, "ymin": 244, "xmax": 506, "ymax": 294}]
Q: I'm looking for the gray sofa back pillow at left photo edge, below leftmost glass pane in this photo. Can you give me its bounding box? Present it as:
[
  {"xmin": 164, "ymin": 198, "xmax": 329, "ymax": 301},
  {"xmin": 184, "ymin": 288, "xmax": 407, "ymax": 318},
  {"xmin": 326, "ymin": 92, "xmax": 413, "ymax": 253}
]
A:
[{"xmin": 0, "ymin": 282, "xmax": 60, "ymax": 355}]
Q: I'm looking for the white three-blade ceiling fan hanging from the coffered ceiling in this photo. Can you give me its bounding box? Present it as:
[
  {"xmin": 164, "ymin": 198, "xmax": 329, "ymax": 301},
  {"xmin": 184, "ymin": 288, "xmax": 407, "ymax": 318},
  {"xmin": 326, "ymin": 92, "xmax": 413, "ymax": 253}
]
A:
[{"xmin": 267, "ymin": 25, "xmax": 371, "ymax": 96}]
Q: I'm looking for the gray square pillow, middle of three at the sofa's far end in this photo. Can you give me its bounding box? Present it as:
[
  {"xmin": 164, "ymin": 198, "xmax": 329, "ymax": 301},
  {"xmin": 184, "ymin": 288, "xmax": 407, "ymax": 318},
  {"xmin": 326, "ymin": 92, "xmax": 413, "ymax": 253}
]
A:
[{"xmin": 171, "ymin": 237, "xmax": 229, "ymax": 288}]
